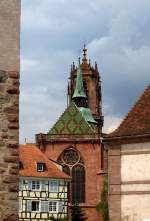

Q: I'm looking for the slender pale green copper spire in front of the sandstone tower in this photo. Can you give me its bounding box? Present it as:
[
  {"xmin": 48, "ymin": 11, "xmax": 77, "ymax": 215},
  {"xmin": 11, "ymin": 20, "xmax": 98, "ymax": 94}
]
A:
[{"xmin": 72, "ymin": 65, "xmax": 87, "ymax": 98}]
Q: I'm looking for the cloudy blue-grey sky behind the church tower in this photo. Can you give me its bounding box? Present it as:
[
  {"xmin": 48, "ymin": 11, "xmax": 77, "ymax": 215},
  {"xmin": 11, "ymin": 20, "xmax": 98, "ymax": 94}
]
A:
[{"xmin": 20, "ymin": 0, "xmax": 150, "ymax": 143}]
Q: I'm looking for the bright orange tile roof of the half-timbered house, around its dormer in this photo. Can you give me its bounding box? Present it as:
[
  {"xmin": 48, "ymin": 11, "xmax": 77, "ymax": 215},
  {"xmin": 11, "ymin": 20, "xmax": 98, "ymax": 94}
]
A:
[{"xmin": 19, "ymin": 144, "xmax": 70, "ymax": 179}]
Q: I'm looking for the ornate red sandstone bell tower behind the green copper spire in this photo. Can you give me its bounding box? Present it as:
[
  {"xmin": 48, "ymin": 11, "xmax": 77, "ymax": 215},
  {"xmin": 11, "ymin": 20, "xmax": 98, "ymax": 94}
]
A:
[{"xmin": 68, "ymin": 45, "xmax": 103, "ymax": 133}]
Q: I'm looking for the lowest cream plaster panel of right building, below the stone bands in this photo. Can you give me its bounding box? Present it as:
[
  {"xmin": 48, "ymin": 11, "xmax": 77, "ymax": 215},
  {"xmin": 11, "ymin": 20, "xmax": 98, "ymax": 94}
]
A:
[{"xmin": 121, "ymin": 194, "xmax": 150, "ymax": 221}]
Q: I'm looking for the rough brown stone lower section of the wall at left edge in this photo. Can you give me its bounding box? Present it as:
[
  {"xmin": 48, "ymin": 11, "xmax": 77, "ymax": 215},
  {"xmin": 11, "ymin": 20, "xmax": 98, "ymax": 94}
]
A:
[{"xmin": 0, "ymin": 71, "xmax": 19, "ymax": 221}]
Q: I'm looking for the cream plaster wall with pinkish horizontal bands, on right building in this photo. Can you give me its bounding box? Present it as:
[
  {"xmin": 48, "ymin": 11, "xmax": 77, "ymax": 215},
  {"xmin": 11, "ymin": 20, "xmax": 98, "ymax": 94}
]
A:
[{"xmin": 121, "ymin": 142, "xmax": 150, "ymax": 221}]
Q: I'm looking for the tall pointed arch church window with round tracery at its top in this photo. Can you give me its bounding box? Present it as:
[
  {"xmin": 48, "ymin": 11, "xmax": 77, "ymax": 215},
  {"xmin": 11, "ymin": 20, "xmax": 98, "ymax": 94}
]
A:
[{"xmin": 58, "ymin": 147, "xmax": 85, "ymax": 203}]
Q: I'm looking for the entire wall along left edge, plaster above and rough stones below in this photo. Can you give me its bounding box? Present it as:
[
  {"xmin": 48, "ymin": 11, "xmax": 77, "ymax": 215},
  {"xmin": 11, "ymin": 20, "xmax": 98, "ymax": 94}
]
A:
[{"xmin": 0, "ymin": 0, "xmax": 21, "ymax": 221}]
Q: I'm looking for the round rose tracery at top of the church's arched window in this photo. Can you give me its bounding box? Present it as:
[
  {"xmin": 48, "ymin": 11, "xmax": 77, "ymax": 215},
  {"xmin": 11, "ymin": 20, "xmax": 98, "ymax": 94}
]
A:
[{"xmin": 63, "ymin": 149, "xmax": 79, "ymax": 165}]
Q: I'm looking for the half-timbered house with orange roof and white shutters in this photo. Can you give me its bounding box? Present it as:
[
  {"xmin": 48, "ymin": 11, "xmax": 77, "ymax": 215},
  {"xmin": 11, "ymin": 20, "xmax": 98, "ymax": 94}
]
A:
[{"xmin": 19, "ymin": 144, "xmax": 70, "ymax": 221}]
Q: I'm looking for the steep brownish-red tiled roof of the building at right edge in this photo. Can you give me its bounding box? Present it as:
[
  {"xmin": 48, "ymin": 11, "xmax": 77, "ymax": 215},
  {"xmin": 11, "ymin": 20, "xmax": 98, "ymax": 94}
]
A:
[{"xmin": 108, "ymin": 84, "xmax": 150, "ymax": 137}]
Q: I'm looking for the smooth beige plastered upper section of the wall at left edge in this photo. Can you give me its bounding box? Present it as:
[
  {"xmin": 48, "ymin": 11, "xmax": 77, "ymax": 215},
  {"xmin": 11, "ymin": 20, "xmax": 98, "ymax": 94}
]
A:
[{"xmin": 0, "ymin": 0, "xmax": 21, "ymax": 71}]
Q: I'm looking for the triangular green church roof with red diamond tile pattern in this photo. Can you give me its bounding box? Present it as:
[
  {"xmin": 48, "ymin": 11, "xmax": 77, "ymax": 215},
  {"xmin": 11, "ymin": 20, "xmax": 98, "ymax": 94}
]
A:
[{"xmin": 48, "ymin": 102, "xmax": 95, "ymax": 137}]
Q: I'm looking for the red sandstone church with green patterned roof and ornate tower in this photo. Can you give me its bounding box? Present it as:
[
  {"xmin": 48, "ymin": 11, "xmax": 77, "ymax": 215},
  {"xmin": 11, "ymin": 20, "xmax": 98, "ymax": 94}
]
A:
[{"xmin": 36, "ymin": 46, "xmax": 106, "ymax": 221}]
